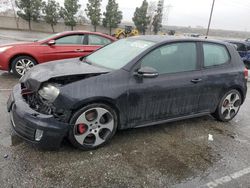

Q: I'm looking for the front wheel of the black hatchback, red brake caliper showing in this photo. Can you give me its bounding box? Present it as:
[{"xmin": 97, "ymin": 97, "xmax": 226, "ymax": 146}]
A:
[{"xmin": 68, "ymin": 103, "xmax": 118, "ymax": 150}]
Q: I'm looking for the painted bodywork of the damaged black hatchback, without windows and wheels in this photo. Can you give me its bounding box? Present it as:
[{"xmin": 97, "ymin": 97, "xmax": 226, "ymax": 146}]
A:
[{"xmin": 9, "ymin": 36, "xmax": 247, "ymax": 148}]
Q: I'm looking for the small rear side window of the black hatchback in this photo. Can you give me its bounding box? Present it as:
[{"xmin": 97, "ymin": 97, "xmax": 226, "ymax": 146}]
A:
[{"xmin": 203, "ymin": 44, "xmax": 230, "ymax": 67}]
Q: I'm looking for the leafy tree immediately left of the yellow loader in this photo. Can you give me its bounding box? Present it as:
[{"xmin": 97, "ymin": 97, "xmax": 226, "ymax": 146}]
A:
[{"xmin": 102, "ymin": 0, "xmax": 122, "ymax": 35}]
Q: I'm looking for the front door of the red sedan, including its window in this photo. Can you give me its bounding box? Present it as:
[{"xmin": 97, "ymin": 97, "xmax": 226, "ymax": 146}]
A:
[{"xmin": 40, "ymin": 34, "xmax": 88, "ymax": 62}]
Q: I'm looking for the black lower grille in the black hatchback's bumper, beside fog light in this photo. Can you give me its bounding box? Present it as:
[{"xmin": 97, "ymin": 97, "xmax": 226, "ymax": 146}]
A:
[{"xmin": 13, "ymin": 109, "xmax": 36, "ymax": 140}]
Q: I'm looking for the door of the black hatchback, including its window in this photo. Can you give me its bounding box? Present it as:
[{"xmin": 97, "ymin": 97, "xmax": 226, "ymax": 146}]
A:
[{"xmin": 128, "ymin": 42, "xmax": 204, "ymax": 127}]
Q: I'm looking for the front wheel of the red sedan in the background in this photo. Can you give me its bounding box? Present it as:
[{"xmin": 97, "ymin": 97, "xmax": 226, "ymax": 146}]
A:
[{"xmin": 11, "ymin": 56, "xmax": 37, "ymax": 77}]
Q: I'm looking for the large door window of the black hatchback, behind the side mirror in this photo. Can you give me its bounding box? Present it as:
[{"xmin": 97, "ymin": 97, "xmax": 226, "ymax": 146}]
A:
[{"xmin": 141, "ymin": 42, "xmax": 197, "ymax": 74}]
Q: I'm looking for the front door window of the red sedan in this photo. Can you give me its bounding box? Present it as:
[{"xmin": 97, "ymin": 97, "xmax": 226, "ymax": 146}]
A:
[{"xmin": 56, "ymin": 35, "xmax": 84, "ymax": 45}]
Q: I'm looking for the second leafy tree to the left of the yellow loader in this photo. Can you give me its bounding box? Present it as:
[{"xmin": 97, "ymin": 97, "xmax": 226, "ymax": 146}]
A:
[{"xmin": 85, "ymin": 0, "xmax": 102, "ymax": 31}]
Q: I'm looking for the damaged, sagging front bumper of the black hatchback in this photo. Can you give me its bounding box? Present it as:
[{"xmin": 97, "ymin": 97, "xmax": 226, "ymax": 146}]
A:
[{"xmin": 7, "ymin": 84, "xmax": 69, "ymax": 148}]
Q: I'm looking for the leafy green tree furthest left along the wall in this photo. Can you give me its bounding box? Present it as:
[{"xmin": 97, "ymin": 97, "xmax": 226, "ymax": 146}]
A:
[{"xmin": 16, "ymin": 0, "xmax": 42, "ymax": 30}]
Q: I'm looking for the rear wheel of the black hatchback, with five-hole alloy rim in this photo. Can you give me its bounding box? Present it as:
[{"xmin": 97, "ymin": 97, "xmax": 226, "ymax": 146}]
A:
[{"xmin": 212, "ymin": 89, "xmax": 242, "ymax": 122}]
